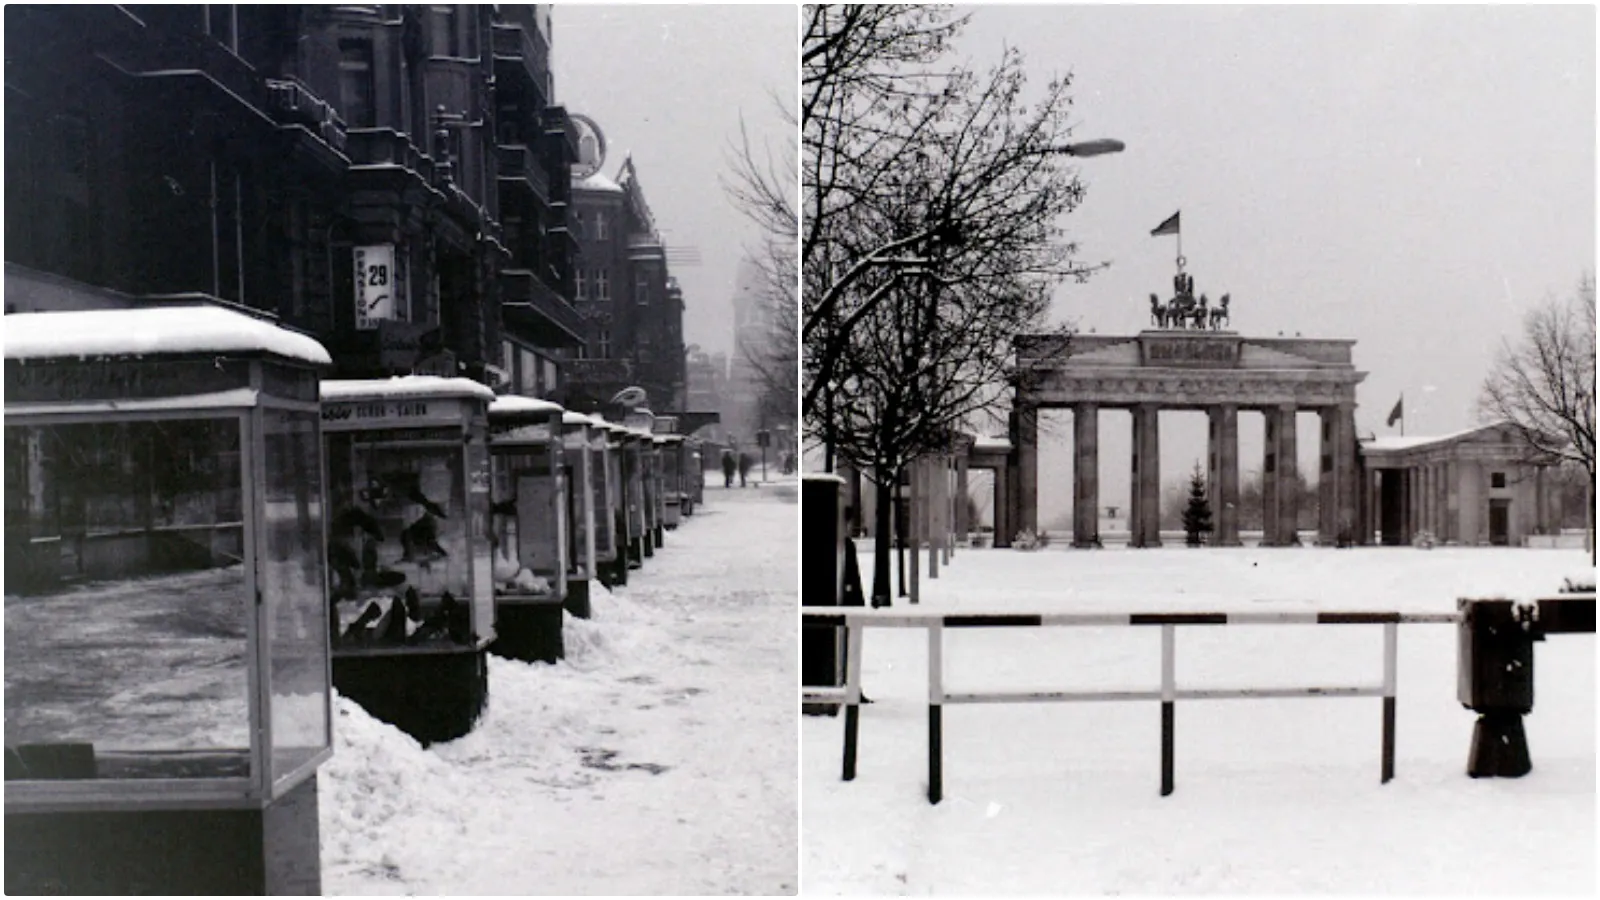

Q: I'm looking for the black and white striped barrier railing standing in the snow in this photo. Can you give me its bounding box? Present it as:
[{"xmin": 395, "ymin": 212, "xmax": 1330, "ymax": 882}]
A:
[{"xmin": 802, "ymin": 607, "xmax": 1461, "ymax": 804}]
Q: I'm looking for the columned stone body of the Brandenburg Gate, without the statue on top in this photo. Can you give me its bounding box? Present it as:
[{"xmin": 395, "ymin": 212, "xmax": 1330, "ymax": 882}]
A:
[{"xmin": 1006, "ymin": 328, "xmax": 1366, "ymax": 548}]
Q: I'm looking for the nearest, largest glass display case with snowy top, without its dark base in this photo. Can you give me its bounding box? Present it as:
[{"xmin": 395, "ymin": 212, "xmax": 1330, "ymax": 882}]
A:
[{"xmin": 5, "ymin": 306, "xmax": 331, "ymax": 815}]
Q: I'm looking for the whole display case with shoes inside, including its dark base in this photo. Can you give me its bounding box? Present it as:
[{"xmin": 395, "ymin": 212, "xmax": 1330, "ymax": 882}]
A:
[{"xmin": 322, "ymin": 375, "xmax": 494, "ymax": 743}]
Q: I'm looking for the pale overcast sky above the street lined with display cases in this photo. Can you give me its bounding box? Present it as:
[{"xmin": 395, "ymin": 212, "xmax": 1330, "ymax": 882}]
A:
[{"xmin": 550, "ymin": 3, "xmax": 800, "ymax": 360}]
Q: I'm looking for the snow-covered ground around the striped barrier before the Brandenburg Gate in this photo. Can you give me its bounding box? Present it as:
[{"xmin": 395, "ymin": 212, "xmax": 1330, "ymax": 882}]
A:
[{"xmin": 802, "ymin": 543, "xmax": 1595, "ymax": 895}]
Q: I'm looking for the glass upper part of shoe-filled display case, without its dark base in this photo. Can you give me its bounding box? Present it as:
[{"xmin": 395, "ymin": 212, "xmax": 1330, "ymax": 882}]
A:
[{"xmin": 322, "ymin": 375, "xmax": 494, "ymax": 657}]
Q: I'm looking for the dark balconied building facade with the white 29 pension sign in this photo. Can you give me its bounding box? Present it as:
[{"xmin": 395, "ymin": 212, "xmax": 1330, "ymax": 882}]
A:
[{"xmin": 5, "ymin": 5, "xmax": 582, "ymax": 389}]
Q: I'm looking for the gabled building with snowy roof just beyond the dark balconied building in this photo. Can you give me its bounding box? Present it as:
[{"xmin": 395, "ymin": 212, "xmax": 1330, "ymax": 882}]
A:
[{"xmin": 568, "ymin": 157, "xmax": 688, "ymax": 413}]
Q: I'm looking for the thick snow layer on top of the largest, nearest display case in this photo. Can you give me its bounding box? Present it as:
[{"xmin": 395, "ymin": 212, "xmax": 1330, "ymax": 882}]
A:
[{"xmin": 5, "ymin": 304, "xmax": 333, "ymax": 365}]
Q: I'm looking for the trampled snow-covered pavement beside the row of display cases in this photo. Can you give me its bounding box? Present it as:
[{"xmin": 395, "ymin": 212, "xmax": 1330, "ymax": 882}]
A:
[{"xmin": 320, "ymin": 480, "xmax": 798, "ymax": 895}]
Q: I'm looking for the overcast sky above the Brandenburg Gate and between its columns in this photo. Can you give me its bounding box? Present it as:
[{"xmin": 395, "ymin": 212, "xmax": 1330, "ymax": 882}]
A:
[{"xmin": 940, "ymin": 5, "xmax": 1595, "ymax": 520}]
